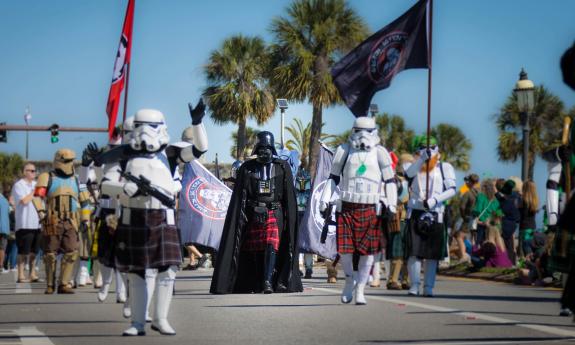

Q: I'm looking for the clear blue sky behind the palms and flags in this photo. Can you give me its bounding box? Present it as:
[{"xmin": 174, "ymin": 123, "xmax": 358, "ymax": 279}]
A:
[{"xmin": 0, "ymin": 0, "xmax": 575, "ymax": 194}]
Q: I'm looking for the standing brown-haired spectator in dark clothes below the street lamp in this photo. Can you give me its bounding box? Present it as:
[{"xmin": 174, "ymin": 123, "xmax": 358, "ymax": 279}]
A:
[{"xmin": 517, "ymin": 180, "xmax": 539, "ymax": 258}]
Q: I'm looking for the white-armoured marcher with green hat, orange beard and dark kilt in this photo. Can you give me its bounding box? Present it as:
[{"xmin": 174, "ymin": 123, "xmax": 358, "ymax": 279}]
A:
[{"xmin": 405, "ymin": 135, "xmax": 456, "ymax": 297}]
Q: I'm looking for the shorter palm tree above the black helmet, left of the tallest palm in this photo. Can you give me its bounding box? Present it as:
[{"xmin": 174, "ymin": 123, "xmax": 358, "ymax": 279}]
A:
[{"xmin": 203, "ymin": 35, "xmax": 275, "ymax": 157}]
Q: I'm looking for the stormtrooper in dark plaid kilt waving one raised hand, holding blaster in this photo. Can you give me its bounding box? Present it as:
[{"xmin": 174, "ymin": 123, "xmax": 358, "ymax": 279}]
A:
[{"xmin": 102, "ymin": 101, "xmax": 208, "ymax": 336}]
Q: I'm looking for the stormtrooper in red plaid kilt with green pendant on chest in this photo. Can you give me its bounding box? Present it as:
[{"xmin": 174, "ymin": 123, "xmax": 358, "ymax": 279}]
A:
[{"xmin": 320, "ymin": 117, "xmax": 397, "ymax": 305}]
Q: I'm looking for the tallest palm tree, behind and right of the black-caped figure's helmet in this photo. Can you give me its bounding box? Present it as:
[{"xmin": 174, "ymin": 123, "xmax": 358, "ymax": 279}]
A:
[{"xmin": 271, "ymin": 0, "xmax": 368, "ymax": 178}]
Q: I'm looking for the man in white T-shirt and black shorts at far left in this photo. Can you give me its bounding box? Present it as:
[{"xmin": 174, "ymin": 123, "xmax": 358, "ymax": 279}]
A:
[{"xmin": 12, "ymin": 163, "xmax": 41, "ymax": 283}]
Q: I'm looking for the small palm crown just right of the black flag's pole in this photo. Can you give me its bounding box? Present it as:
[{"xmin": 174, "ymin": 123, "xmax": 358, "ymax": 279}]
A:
[{"xmin": 431, "ymin": 123, "xmax": 473, "ymax": 171}]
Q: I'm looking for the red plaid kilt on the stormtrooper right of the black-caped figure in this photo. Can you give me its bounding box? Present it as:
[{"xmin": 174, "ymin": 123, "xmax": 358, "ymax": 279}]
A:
[{"xmin": 337, "ymin": 202, "xmax": 382, "ymax": 255}]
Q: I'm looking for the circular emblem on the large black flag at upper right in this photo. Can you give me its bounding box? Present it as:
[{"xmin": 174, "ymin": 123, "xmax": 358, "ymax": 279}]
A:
[{"xmin": 367, "ymin": 31, "xmax": 409, "ymax": 83}]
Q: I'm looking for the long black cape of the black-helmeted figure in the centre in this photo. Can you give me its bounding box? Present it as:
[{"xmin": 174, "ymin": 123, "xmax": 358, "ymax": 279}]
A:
[{"xmin": 210, "ymin": 159, "xmax": 303, "ymax": 294}]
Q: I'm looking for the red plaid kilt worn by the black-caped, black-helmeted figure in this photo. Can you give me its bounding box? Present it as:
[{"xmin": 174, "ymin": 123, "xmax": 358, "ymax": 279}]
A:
[{"xmin": 242, "ymin": 210, "xmax": 280, "ymax": 252}]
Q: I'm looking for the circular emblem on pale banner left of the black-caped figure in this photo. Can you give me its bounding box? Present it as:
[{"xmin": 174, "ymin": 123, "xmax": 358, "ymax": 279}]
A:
[{"xmin": 186, "ymin": 176, "xmax": 232, "ymax": 220}]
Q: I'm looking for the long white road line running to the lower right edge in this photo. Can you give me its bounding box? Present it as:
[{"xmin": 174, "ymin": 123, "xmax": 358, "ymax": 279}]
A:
[{"xmin": 313, "ymin": 287, "xmax": 575, "ymax": 338}]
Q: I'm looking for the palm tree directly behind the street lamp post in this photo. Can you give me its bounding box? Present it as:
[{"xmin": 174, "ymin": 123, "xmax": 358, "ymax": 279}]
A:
[{"xmin": 493, "ymin": 86, "xmax": 566, "ymax": 179}]
